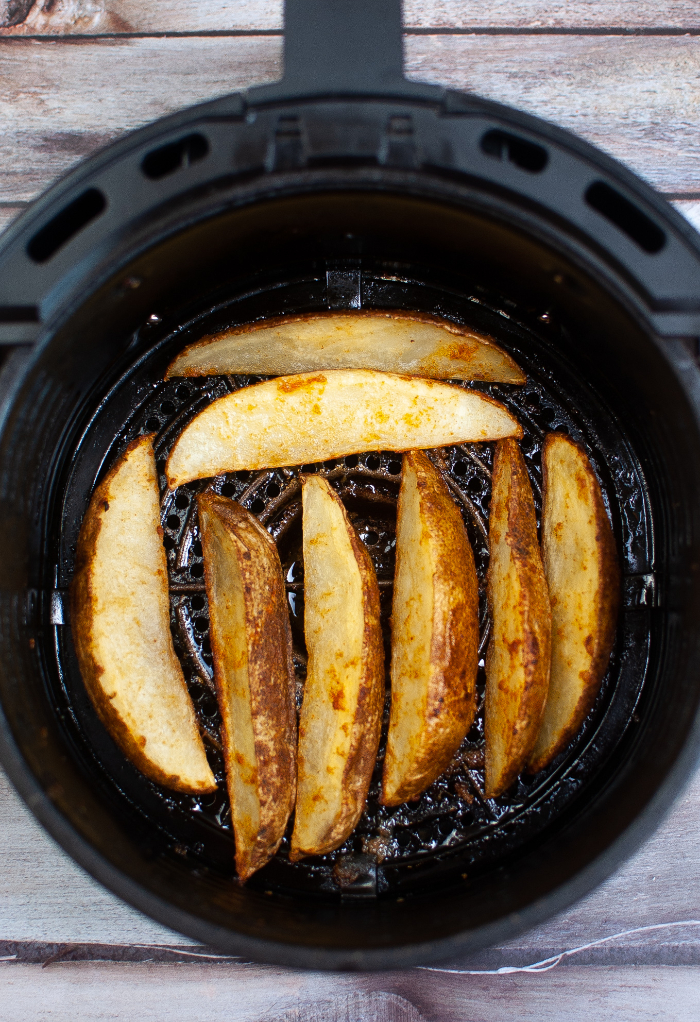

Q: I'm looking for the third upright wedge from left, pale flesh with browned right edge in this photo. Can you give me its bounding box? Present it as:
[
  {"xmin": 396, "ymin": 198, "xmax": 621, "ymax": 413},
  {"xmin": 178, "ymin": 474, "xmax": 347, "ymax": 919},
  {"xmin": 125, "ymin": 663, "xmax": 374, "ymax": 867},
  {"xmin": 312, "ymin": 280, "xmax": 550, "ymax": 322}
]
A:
[{"xmin": 291, "ymin": 475, "xmax": 384, "ymax": 860}]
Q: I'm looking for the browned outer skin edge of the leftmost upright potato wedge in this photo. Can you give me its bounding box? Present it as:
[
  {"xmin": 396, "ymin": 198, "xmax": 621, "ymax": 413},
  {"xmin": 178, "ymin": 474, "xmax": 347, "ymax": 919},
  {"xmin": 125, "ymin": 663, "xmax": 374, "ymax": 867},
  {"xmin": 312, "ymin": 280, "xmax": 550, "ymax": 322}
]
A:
[{"xmin": 69, "ymin": 433, "xmax": 217, "ymax": 794}]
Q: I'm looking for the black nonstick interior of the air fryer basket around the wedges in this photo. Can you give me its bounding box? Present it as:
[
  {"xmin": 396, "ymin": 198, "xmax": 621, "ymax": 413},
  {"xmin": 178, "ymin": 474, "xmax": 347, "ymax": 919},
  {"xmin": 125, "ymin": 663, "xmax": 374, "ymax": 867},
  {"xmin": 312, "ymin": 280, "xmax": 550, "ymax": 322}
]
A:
[{"xmin": 0, "ymin": 188, "xmax": 700, "ymax": 968}]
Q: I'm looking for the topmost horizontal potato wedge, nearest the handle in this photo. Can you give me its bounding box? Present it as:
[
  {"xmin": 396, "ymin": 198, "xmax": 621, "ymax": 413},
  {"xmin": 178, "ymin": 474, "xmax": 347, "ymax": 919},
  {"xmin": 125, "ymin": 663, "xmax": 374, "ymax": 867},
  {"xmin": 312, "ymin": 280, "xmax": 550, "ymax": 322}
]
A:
[{"xmin": 166, "ymin": 310, "xmax": 525, "ymax": 383}]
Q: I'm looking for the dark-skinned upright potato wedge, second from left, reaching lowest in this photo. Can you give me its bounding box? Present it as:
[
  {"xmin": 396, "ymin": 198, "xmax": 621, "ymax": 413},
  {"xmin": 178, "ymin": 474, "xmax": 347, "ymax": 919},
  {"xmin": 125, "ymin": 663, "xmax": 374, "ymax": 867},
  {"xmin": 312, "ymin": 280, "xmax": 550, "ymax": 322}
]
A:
[{"xmin": 197, "ymin": 494, "xmax": 296, "ymax": 880}]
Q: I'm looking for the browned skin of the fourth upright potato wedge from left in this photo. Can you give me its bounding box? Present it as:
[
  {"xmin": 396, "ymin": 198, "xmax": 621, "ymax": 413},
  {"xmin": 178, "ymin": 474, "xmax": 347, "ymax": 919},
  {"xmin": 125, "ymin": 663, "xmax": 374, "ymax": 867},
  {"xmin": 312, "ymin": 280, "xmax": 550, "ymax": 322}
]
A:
[{"xmin": 382, "ymin": 451, "xmax": 479, "ymax": 805}]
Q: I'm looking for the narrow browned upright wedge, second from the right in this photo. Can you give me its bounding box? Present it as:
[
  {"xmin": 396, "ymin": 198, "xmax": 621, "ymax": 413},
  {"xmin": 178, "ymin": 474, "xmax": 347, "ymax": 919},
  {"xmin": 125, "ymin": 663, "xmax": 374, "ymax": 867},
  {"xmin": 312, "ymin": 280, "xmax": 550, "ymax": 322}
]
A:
[{"xmin": 484, "ymin": 439, "xmax": 552, "ymax": 798}]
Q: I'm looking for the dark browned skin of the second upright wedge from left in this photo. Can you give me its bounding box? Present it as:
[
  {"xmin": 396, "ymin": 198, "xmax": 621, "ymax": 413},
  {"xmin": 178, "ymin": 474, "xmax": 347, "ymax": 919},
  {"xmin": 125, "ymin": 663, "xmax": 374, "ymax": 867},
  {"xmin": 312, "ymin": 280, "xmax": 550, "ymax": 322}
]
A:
[{"xmin": 197, "ymin": 493, "xmax": 296, "ymax": 882}]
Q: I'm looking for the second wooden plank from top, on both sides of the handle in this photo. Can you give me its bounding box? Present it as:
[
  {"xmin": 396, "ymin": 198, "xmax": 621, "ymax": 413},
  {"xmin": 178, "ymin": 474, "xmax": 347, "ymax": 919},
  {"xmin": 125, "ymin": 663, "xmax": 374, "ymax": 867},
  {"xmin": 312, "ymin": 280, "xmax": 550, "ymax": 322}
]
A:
[{"xmin": 0, "ymin": 36, "xmax": 700, "ymax": 202}]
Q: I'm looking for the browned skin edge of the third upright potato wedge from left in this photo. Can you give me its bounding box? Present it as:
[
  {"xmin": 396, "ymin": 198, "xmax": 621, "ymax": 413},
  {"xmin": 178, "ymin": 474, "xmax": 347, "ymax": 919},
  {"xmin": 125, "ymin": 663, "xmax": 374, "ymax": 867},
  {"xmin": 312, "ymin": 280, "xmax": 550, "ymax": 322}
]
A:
[{"xmin": 289, "ymin": 476, "xmax": 385, "ymax": 862}]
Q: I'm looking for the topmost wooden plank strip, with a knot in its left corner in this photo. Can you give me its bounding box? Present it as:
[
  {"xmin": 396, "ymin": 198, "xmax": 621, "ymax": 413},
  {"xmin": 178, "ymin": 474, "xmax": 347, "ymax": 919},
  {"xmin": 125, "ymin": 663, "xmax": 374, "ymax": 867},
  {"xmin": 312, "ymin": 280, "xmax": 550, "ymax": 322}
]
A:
[{"xmin": 0, "ymin": 0, "xmax": 700, "ymax": 35}]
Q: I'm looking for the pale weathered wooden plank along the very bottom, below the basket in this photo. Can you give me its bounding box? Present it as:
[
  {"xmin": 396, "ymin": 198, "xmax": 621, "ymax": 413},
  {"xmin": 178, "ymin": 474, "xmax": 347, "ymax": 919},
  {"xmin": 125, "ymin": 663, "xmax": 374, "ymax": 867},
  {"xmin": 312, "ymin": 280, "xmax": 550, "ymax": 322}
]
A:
[{"xmin": 0, "ymin": 963, "xmax": 700, "ymax": 1022}]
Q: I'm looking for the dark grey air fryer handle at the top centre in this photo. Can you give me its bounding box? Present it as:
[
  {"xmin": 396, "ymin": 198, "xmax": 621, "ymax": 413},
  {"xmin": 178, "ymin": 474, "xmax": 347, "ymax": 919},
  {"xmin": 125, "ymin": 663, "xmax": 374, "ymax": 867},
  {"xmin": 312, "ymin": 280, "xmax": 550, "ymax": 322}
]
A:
[{"xmin": 249, "ymin": 0, "xmax": 440, "ymax": 102}]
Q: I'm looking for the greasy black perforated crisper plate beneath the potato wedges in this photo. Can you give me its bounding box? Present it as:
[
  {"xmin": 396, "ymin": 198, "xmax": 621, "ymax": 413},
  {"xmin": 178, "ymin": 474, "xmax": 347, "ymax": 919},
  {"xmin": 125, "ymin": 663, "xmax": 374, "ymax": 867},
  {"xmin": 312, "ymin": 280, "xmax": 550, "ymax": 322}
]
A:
[{"xmin": 53, "ymin": 273, "xmax": 651, "ymax": 896}]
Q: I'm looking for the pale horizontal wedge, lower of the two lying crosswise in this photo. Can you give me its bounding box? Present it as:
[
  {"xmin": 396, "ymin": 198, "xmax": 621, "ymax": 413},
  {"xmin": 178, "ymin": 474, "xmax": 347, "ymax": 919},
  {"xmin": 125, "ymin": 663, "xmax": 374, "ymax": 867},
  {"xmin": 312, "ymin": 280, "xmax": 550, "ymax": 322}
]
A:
[{"xmin": 166, "ymin": 369, "xmax": 522, "ymax": 489}]
